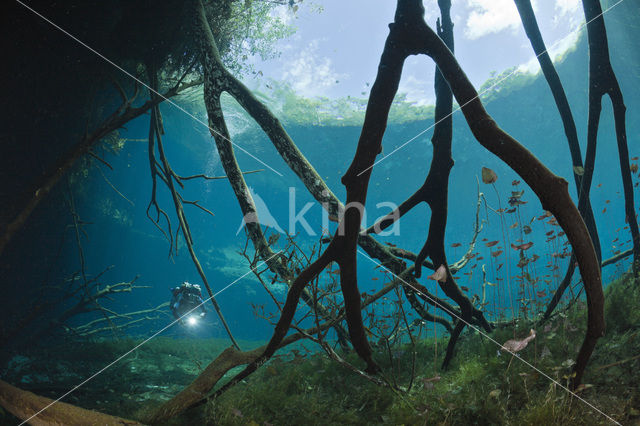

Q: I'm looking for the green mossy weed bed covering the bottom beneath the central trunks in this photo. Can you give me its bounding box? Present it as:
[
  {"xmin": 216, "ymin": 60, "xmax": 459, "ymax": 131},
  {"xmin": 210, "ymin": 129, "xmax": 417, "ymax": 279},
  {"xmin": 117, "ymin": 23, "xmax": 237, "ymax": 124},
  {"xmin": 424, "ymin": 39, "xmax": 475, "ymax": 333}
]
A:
[{"xmin": 203, "ymin": 275, "xmax": 640, "ymax": 425}]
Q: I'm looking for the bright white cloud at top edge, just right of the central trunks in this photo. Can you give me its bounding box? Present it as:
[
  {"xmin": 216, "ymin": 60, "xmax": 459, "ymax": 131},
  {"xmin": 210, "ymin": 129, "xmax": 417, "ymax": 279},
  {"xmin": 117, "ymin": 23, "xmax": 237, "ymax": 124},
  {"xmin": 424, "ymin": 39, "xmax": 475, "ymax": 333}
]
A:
[{"xmin": 464, "ymin": 0, "xmax": 522, "ymax": 40}]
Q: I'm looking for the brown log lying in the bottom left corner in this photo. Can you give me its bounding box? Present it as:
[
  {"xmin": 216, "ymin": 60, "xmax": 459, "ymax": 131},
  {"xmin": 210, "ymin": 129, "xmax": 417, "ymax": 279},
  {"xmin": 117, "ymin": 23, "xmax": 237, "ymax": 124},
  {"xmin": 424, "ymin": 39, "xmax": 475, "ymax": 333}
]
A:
[{"xmin": 0, "ymin": 380, "xmax": 142, "ymax": 426}]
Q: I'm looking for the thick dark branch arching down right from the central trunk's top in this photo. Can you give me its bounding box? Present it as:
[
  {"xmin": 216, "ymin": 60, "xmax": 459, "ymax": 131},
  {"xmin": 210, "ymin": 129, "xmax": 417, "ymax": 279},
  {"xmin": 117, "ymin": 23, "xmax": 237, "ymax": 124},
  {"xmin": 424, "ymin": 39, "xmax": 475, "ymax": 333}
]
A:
[{"xmin": 398, "ymin": 0, "xmax": 605, "ymax": 388}]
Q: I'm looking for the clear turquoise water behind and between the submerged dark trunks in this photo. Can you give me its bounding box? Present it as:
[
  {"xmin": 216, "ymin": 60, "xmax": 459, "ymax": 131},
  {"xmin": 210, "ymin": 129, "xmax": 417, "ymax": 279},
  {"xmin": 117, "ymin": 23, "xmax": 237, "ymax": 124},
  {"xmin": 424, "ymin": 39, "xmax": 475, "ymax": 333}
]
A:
[{"xmin": 0, "ymin": 0, "xmax": 640, "ymax": 424}]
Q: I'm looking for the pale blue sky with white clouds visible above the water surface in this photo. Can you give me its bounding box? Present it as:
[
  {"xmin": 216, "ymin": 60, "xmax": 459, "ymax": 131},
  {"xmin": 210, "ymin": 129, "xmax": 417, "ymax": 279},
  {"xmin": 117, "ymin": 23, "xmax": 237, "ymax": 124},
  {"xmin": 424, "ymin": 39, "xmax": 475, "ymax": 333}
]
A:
[{"xmin": 249, "ymin": 0, "xmax": 584, "ymax": 105}]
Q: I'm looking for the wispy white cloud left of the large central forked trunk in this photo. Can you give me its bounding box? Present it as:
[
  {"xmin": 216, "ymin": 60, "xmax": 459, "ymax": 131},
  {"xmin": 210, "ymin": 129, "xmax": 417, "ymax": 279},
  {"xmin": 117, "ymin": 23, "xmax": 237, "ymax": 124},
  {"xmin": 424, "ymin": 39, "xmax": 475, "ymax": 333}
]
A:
[{"xmin": 282, "ymin": 40, "xmax": 348, "ymax": 97}]
